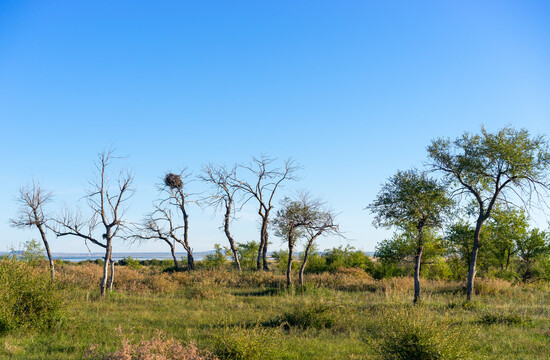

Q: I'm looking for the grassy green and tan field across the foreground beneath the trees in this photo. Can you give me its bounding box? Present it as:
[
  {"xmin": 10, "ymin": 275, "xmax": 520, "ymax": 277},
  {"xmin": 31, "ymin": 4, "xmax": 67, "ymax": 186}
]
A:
[{"xmin": 0, "ymin": 263, "xmax": 550, "ymax": 359}]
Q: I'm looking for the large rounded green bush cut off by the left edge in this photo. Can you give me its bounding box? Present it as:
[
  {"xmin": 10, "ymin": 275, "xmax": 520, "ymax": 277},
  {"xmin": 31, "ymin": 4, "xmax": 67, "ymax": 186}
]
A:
[{"xmin": 0, "ymin": 259, "xmax": 62, "ymax": 333}]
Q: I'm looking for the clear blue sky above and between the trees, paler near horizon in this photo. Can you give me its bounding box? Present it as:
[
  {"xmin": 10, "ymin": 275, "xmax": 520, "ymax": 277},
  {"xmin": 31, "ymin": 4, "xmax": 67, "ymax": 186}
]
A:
[{"xmin": 0, "ymin": 0, "xmax": 550, "ymax": 252}]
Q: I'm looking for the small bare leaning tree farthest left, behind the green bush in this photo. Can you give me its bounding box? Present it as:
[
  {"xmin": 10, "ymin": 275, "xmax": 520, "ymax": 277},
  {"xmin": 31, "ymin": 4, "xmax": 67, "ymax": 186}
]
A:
[{"xmin": 10, "ymin": 181, "xmax": 55, "ymax": 281}]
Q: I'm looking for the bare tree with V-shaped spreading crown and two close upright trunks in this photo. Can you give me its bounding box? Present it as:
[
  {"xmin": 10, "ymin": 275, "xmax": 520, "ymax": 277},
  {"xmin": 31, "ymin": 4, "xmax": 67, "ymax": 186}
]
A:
[{"xmin": 231, "ymin": 155, "xmax": 298, "ymax": 270}]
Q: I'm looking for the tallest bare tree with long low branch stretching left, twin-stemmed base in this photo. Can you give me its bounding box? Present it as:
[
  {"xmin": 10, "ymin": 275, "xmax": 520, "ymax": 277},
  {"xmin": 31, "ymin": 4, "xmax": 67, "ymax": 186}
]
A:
[{"xmin": 55, "ymin": 150, "xmax": 134, "ymax": 296}]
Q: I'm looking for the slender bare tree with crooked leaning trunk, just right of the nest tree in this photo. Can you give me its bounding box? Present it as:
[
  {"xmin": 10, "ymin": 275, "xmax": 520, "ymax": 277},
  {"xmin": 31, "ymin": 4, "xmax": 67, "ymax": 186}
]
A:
[{"xmin": 199, "ymin": 165, "xmax": 241, "ymax": 271}]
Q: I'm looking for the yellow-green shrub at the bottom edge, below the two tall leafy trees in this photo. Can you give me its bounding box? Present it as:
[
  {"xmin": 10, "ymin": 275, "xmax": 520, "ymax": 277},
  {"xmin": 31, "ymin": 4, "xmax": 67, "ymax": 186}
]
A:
[{"xmin": 376, "ymin": 307, "xmax": 472, "ymax": 360}]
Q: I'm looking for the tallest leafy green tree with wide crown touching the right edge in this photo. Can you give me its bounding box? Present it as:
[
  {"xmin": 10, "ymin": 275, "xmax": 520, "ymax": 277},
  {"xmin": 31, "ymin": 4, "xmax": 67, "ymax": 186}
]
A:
[{"xmin": 428, "ymin": 127, "xmax": 550, "ymax": 300}]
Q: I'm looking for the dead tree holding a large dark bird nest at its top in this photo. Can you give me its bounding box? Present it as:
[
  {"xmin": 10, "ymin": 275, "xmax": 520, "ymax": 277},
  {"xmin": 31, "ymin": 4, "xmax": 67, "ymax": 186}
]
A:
[{"xmin": 162, "ymin": 169, "xmax": 196, "ymax": 270}]
